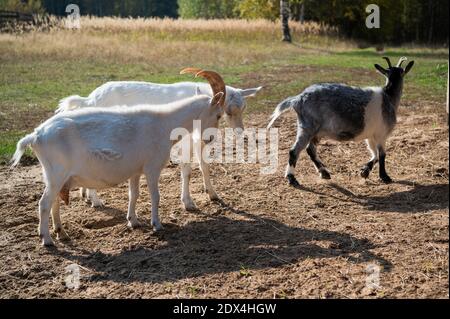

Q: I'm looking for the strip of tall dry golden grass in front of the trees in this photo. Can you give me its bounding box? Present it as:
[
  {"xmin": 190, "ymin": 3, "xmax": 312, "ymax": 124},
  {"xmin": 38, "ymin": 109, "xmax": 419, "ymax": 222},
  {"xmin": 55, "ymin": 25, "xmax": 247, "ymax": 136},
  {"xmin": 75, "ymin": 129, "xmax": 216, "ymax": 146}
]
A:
[{"xmin": 0, "ymin": 17, "xmax": 347, "ymax": 67}]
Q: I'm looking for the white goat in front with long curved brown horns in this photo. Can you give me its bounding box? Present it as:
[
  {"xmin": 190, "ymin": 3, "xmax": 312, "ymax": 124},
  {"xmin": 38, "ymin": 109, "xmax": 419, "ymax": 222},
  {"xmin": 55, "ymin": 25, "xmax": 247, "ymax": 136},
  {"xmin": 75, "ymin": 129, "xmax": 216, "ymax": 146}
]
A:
[{"xmin": 12, "ymin": 69, "xmax": 226, "ymax": 246}]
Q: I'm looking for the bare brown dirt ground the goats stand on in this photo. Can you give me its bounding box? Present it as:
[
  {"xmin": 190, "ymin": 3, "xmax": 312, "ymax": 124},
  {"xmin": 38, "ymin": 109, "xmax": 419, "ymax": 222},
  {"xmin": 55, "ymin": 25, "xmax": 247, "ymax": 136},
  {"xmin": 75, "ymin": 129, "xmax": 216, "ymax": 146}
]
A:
[{"xmin": 0, "ymin": 105, "xmax": 449, "ymax": 298}]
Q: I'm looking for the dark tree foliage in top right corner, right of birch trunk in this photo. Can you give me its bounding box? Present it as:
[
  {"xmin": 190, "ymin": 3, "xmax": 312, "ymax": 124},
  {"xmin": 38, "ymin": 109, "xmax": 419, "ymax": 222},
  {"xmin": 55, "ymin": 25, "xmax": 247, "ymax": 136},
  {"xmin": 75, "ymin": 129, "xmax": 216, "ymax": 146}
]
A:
[{"xmin": 303, "ymin": 0, "xmax": 449, "ymax": 44}]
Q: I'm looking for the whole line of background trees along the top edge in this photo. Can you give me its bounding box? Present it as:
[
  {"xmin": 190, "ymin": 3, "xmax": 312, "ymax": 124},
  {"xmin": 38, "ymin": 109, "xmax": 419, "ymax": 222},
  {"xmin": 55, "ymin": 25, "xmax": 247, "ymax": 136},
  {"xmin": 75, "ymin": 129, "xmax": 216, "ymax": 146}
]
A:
[{"xmin": 0, "ymin": 0, "xmax": 449, "ymax": 45}]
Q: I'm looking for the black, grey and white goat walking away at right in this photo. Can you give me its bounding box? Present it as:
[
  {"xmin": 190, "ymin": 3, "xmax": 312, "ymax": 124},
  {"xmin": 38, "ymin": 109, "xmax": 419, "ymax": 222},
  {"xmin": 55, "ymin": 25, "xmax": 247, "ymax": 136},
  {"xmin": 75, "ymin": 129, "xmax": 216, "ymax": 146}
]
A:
[{"xmin": 268, "ymin": 57, "xmax": 414, "ymax": 186}]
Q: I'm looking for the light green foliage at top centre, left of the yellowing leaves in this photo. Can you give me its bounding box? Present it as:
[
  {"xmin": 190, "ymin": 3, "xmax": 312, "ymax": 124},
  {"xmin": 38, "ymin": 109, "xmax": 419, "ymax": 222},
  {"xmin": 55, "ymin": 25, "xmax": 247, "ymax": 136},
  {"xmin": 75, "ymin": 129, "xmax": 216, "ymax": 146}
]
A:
[{"xmin": 178, "ymin": 0, "xmax": 238, "ymax": 19}]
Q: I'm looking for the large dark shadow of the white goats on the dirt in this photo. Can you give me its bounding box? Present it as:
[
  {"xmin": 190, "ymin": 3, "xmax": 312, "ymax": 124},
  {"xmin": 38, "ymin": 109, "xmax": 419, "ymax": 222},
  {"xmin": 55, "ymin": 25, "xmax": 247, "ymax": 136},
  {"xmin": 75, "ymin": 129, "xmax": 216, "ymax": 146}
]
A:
[{"xmin": 55, "ymin": 210, "xmax": 391, "ymax": 283}]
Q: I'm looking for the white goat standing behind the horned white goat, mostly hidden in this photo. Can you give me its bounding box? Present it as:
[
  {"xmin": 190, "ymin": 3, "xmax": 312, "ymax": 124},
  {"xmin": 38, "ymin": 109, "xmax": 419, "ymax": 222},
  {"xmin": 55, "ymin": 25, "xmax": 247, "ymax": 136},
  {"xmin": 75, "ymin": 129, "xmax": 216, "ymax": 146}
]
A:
[{"xmin": 56, "ymin": 82, "xmax": 262, "ymax": 210}]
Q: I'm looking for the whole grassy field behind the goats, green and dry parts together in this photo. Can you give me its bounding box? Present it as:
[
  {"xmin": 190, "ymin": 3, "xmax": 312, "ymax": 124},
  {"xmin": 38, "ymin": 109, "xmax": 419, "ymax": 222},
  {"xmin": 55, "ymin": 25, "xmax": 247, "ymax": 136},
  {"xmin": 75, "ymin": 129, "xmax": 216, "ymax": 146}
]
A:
[{"xmin": 0, "ymin": 19, "xmax": 448, "ymax": 163}]
